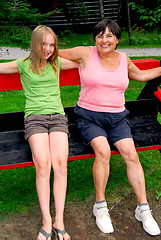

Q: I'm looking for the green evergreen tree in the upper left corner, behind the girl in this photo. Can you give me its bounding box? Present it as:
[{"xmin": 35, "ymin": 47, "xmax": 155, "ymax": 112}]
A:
[{"xmin": 0, "ymin": 0, "xmax": 53, "ymax": 48}]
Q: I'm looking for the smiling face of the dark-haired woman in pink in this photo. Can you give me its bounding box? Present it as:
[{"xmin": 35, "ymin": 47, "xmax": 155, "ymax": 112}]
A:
[{"xmin": 95, "ymin": 27, "xmax": 119, "ymax": 54}]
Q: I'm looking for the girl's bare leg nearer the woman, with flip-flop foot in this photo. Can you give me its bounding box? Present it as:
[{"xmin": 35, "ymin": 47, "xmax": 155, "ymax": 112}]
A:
[{"xmin": 49, "ymin": 132, "xmax": 70, "ymax": 240}]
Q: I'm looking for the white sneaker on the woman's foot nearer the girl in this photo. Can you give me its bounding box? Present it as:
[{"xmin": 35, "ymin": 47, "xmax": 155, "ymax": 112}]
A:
[{"xmin": 93, "ymin": 204, "xmax": 114, "ymax": 233}]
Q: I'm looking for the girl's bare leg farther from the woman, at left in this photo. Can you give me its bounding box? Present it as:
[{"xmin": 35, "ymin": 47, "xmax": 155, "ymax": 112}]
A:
[{"xmin": 29, "ymin": 133, "xmax": 52, "ymax": 240}]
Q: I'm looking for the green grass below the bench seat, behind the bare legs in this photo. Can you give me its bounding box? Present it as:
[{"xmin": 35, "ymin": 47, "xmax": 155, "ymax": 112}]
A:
[{"xmin": 0, "ymin": 150, "xmax": 161, "ymax": 214}]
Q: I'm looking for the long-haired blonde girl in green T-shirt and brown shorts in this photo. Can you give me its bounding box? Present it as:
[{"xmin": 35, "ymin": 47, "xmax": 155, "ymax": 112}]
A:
[{"xmin": 0, "ymin": 26, "xmax": 78, "ymax": 240}]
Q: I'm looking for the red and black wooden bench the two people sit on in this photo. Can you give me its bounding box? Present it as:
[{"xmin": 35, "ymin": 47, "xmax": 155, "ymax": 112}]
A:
[{"xmin": 0, "ymin": 58, "xmax": 161, "ymax": 170}]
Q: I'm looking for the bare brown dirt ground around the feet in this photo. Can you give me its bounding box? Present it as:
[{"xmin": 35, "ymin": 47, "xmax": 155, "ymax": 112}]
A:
[{"xmin": 0, "ymin": 194, "xmax": 161, "ymax": 240}]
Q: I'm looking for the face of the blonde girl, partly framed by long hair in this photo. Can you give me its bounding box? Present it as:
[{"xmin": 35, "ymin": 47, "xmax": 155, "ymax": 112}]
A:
[{"xmin": 42, "ymin": 34, "xmax": 55, "ymax": 60}]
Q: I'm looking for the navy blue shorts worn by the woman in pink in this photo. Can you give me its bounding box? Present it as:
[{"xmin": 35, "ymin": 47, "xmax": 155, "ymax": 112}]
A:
[{"xmin": 74, "ymin": 105, "xmax": 132, "ymax": 145}]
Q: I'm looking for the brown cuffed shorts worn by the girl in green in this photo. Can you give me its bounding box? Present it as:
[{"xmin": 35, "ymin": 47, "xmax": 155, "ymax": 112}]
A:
[{"xmin": 24, "ymin": 114, "xmax": 69, "ymax": 139}]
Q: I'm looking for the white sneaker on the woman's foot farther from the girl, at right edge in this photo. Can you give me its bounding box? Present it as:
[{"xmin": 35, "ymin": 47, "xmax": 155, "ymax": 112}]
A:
[{"xmin": 135, "ymin": 205, "xmax": 160, "ymax": 236}]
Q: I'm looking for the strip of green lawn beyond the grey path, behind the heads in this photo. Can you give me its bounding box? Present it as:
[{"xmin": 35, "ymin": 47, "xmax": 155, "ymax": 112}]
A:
[{"xmin": 0, "ymin": 29, "xmax": 161, "ymax": 49}]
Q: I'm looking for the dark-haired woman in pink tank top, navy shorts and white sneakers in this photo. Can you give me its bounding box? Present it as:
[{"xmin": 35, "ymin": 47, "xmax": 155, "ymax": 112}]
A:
[{"xmin": 59, "ymin": 19, "xmax": 161, "ymax": 235}]
